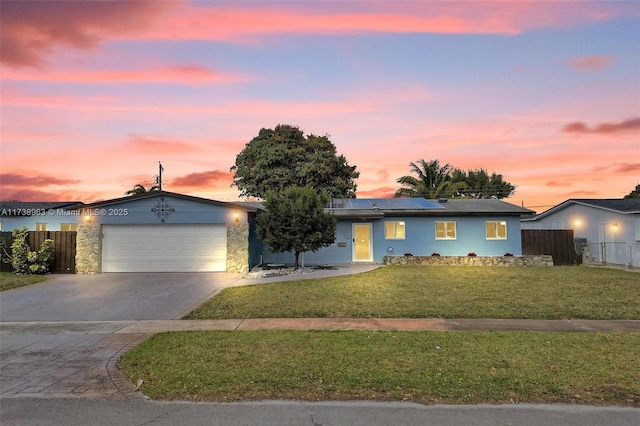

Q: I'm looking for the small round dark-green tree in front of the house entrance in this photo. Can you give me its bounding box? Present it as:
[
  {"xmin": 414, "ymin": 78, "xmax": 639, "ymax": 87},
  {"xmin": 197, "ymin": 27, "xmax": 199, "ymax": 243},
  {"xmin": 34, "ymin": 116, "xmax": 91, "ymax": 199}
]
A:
[{"xmin": 257, "ymin": 185, "xmax": 336, "ymax": 269}]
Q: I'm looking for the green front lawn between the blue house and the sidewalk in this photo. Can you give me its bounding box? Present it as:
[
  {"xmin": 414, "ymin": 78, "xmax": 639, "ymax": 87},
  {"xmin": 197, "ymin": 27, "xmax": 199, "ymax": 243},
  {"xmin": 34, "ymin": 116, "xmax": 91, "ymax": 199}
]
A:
[{"xmin": 186, "ymin": 266, "xmax": 640, "ymax": 320}]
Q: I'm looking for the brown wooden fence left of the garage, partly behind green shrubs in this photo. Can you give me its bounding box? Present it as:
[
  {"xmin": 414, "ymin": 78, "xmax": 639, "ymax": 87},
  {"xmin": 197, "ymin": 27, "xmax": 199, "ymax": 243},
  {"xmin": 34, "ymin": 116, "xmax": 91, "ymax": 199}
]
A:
[{"xmin": 0, "ymin": 231, "xmax": 77, "ymax": 274}]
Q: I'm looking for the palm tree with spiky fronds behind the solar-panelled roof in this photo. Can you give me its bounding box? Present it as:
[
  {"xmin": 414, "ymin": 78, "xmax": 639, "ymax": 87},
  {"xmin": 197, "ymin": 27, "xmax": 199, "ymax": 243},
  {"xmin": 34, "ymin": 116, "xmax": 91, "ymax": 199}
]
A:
[{"xmin": 394, "ymin": 159, "xmax": 466, "ymax": 199}]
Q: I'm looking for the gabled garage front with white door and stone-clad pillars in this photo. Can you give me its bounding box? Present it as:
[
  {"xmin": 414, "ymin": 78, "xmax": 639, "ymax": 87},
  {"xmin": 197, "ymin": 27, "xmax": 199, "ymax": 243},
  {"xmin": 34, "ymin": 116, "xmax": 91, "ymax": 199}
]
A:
[{"xmin": 63, "ymin": 191, "xmax": 256, "ymax": 273}]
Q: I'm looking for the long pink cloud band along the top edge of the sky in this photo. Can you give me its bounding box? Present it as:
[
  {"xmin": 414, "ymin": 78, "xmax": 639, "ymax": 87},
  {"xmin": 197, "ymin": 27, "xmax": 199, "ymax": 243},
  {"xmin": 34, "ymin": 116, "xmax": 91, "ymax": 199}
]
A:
[{"xmin": 0, "ymin": 1, "xmax": 637, "ymax": 67}]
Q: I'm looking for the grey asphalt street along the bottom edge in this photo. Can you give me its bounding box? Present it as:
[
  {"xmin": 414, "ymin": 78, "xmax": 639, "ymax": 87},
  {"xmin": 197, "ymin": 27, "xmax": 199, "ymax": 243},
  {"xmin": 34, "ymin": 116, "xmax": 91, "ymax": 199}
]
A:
[{"xmin": 0, "ymin": 399, "xmax": 640, "ymax": 426}]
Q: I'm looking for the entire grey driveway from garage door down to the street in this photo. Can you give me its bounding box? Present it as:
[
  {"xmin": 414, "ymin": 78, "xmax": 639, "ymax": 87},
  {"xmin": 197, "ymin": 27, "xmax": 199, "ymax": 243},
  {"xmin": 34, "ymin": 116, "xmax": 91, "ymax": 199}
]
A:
[{"xmin": 0, "ymin": 273, "xmax": 240, "ymax": 399}]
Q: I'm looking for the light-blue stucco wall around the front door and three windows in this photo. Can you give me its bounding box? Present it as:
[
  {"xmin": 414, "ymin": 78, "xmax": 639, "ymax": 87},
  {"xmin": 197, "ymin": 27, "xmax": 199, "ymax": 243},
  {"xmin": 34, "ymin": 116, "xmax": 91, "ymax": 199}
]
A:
[{"xmin": 262, "ymin": 216, "xmax": 522, "ymax": 265}]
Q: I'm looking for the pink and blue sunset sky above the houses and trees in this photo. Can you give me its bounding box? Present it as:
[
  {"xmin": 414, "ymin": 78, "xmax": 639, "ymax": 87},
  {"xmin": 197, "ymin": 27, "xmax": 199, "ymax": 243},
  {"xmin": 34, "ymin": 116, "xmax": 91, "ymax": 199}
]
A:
[{"xmin": 0, "ymin": 0, "xmax": 640, "ymax": 212}]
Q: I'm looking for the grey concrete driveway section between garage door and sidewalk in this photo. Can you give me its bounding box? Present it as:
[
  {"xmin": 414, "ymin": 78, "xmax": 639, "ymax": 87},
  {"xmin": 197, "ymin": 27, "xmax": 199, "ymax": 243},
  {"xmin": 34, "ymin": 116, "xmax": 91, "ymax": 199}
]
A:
[{"xmin": 0, "ymin": 272, "xmax": 241, "ymax": 322}]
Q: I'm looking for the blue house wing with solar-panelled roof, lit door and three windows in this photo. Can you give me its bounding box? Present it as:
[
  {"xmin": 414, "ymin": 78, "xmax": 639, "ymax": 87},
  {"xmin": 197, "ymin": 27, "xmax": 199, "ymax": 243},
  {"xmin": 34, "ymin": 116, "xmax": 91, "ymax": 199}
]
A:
[{"xmin": 262, "ymin": 198, "xmax": 535, "ymax": 264}]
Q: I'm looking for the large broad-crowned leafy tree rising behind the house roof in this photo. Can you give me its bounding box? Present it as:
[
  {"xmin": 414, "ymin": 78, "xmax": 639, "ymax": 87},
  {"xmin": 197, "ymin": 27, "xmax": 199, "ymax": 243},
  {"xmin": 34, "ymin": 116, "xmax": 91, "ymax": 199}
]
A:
[{"xmin": 231, "ymin": 124, "xmax": 360, "ymax": 199}]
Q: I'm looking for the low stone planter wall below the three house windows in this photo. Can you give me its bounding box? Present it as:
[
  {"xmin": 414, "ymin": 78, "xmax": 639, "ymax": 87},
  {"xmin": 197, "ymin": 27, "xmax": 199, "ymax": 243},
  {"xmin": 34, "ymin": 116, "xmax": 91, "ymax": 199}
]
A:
[{"xmin": 383, "ymin": 255, "xmax": 553, "ymax": 266}]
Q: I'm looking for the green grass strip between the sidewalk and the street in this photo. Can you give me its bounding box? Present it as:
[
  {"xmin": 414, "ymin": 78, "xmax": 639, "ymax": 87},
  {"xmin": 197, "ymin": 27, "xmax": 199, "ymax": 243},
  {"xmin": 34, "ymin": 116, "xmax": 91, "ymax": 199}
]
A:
[{"xmin": 120, "ymin": 331, "xmax": 640, "ymax": 406}]
